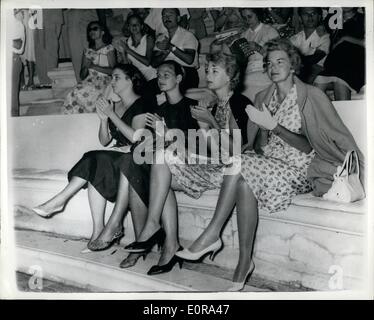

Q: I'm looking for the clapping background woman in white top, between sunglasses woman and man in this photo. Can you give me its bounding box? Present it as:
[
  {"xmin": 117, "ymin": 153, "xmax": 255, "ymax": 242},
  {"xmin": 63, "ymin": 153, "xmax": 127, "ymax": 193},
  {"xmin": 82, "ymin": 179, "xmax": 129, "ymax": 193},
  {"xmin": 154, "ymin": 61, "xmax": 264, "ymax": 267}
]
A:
[{"xmin": 114, "ymin": 14, "xmax": 157, "ymax": 81}]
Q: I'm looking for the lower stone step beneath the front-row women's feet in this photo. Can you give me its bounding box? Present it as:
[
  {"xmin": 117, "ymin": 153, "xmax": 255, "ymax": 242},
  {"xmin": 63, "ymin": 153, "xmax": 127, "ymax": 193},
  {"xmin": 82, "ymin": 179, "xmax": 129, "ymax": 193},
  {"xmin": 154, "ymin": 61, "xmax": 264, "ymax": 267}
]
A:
[{"xmin": 16, "ymin": 230, "xmax": 267, "ymax": 292}]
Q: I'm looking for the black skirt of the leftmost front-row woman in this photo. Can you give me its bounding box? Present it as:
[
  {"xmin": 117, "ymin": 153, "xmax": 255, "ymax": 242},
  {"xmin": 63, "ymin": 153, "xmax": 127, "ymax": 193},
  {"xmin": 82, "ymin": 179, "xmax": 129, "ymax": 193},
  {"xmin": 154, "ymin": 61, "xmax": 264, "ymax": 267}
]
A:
[{"xmin": 68, "ymin": 150, "xmax": 126, "ymax": 202}]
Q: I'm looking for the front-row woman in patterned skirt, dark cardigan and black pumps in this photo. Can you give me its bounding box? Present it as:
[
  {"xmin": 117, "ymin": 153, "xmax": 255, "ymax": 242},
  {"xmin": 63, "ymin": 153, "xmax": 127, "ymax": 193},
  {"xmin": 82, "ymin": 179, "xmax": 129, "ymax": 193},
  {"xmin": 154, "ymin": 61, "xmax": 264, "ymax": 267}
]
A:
[{"xmin": 125, "ymin": 52, "xmax": 250, "ymax": 275}]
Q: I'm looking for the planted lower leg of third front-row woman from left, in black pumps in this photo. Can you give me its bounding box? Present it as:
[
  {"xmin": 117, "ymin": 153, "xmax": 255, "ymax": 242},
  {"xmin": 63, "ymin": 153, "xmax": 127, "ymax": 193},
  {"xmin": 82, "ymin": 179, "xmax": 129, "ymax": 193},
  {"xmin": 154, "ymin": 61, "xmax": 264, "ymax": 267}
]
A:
[{"xmin": 158, "ymin": 189, "xmax": 179, "ymax": 266}]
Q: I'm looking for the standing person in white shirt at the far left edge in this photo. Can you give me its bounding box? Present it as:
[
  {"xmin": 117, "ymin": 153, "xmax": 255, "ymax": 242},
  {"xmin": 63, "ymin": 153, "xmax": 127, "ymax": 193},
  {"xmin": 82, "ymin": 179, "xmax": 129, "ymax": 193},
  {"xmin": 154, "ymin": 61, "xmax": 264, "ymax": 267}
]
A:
[{"xmin": 9, "ymin": 9, "xmax": 26, "ymax": 117}]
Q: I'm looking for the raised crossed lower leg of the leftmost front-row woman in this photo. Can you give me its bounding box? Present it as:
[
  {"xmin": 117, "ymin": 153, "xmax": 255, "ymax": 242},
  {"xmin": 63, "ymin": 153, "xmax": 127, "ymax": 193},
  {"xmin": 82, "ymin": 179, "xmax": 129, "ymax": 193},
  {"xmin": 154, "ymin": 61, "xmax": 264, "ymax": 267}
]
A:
[{"xmin": 38, "ymin": 177, "xmax": 87, "ymax": 212}]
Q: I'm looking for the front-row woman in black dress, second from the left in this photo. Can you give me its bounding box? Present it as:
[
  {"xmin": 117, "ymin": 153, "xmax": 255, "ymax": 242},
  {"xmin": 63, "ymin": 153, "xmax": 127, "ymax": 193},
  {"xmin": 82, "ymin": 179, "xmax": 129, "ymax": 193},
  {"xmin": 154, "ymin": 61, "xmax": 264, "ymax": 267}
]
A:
[{"xmin": 103, "ymin": 60, "xmax": 198, "ymax": 268}]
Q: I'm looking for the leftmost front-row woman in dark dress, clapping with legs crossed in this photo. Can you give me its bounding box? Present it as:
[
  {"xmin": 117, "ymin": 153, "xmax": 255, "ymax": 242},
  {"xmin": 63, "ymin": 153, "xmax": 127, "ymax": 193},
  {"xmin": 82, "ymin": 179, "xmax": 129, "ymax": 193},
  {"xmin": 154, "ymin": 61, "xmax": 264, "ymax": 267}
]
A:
[{"xmin": 33, "ymin": 64, "xmax": 146, "ymax": 250}]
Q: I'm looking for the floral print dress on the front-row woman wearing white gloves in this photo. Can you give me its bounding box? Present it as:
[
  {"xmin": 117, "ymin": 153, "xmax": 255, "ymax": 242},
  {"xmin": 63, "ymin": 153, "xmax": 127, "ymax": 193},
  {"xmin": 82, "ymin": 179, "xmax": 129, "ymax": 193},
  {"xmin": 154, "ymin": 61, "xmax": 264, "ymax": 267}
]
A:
[{"xmin": 241, "ymin": 85, "xmax": 314, "ymax": 213}]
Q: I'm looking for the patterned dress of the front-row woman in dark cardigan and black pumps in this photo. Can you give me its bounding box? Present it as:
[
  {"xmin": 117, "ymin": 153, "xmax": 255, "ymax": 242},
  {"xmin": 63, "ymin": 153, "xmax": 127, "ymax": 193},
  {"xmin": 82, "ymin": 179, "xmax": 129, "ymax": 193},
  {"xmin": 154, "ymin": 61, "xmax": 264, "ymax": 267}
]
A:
[{"xmin": 165, "ymin": 95, "xmax": 235, "ymax": 199}]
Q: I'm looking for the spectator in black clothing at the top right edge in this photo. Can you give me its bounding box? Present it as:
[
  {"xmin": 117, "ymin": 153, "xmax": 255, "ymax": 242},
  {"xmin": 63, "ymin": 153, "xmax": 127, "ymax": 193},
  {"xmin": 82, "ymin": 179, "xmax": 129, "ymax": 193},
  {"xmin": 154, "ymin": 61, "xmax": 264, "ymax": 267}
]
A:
[{"xmin": 314, "ymin": 7, "xmax": 365, "ymax": 100}]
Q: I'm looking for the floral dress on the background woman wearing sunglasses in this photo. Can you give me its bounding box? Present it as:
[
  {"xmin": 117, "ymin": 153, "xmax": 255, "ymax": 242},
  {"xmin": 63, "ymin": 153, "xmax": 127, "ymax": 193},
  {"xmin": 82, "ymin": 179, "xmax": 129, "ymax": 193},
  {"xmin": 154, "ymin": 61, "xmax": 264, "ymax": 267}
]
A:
[{"xmin": 63, "ymin": 45, "xmax": 114, "ymax": 114}]
